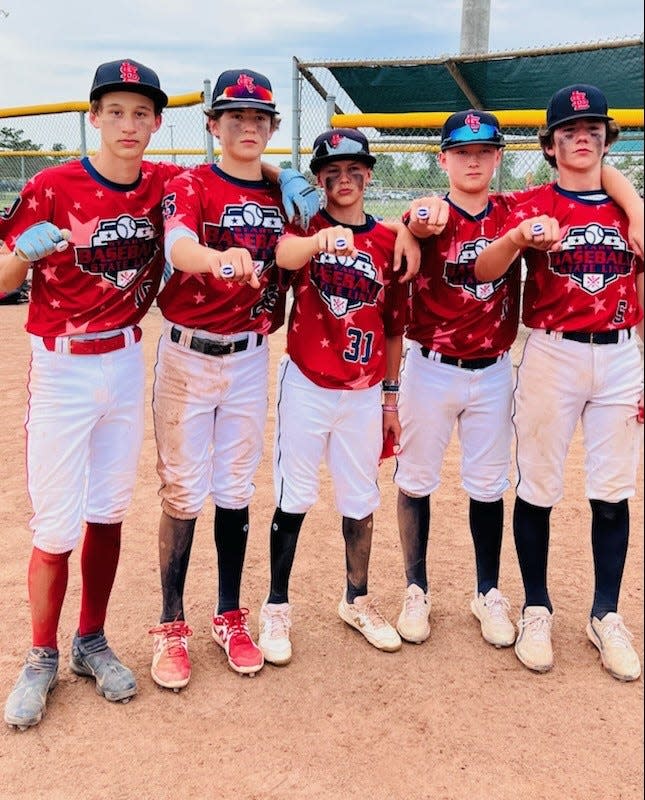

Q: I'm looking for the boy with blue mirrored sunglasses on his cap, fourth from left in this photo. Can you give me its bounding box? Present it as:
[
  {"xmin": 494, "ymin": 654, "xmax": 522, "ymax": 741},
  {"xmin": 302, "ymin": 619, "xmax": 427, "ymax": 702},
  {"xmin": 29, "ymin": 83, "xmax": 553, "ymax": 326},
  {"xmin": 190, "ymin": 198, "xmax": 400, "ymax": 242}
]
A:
[{"xmin": 394, "ymin": 109, "xmax": 634, "ymax": 647}]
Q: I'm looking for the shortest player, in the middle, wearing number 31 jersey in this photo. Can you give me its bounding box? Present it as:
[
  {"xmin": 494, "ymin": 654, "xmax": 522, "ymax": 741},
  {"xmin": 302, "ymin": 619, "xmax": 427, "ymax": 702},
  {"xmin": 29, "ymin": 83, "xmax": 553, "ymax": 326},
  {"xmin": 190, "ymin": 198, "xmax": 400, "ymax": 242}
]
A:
[{"xmin": 259, "ymin": 128, "xmax": 428, "ymax": 664}]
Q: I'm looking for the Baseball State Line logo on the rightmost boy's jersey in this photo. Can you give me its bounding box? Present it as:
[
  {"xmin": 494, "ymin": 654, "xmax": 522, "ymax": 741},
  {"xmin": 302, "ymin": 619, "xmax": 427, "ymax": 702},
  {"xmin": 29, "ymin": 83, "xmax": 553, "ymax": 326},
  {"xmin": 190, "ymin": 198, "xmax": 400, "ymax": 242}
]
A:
[{"xmin": 548, "ymin": 223, "xmax": 633, "ymax": 295}]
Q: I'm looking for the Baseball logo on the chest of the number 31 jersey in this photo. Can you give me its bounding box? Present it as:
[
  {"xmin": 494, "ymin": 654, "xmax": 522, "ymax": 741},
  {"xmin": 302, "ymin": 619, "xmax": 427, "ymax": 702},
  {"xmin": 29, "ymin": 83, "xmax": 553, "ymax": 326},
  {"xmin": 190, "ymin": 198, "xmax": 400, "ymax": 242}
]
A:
[{"xmin": 310, "ymin": 252, "xmax": 383, "ymax": 318}]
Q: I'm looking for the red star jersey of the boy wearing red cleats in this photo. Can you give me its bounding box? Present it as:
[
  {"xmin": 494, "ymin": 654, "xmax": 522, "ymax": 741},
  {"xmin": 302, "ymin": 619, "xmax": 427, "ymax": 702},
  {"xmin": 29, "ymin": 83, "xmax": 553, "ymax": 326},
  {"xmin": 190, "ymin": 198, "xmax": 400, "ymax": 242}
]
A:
[{"xmin": 158, "ymin": 164, "xmax": 286, "ymax": 334}]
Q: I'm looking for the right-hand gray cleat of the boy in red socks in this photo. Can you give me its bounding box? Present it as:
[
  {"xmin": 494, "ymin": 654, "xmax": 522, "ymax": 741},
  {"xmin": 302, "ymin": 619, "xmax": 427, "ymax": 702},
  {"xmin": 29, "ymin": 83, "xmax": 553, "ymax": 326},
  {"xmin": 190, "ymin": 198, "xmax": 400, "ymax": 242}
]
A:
[{"xmin": 69, "ymin": 630, "xmax": 137, "ymax": 703}]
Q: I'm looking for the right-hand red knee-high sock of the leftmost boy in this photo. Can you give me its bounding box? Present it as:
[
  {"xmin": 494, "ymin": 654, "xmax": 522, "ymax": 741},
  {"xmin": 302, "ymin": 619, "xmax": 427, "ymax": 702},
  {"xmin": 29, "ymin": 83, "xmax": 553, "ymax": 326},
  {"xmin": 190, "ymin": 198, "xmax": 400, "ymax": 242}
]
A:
[{"xmin": 78, "ymin": 522, "xmax": 121, "ymax": 636}]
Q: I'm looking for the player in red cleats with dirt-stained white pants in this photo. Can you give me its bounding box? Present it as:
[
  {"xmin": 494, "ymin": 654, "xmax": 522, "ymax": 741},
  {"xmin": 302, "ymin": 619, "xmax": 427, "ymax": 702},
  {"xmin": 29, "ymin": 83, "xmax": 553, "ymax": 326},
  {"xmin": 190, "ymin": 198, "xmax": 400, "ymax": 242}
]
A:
[{"xmin": 151, "ymin": 69, "xmax": 318, "ymax": 690}]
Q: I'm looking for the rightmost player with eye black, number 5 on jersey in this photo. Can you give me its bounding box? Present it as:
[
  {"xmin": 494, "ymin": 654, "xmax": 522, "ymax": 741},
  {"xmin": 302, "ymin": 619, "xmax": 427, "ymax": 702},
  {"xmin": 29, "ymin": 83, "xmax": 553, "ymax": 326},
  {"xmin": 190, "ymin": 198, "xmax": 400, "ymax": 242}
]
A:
[{"xmin": 475, "ymin": 84, "xmax": 643, "ymax": 681}]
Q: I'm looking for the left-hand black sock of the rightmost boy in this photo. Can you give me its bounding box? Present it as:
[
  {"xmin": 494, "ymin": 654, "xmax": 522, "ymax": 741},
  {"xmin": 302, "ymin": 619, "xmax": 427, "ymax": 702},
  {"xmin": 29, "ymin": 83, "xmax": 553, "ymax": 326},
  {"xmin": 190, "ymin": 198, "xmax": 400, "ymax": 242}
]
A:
[{"xmin": 513, "ymin": 497, "xmax": 553, "ymax": 613}]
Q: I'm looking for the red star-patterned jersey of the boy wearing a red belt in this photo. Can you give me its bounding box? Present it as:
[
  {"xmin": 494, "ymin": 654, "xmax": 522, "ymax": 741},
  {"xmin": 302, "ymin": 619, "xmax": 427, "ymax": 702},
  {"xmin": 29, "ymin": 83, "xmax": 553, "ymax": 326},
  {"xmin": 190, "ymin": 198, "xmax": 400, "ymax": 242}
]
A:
[{"xmin": 0, "ymin": 158, "xmax": 179, "ymax": 336}]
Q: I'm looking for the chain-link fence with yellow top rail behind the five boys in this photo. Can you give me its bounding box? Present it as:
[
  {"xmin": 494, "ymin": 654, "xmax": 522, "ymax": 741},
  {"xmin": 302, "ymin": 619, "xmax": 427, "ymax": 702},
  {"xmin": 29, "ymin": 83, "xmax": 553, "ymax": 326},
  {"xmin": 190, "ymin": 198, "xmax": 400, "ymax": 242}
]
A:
[{"xmin": 0, "ymin": 42, "xmax": 643, "ymax": 217}]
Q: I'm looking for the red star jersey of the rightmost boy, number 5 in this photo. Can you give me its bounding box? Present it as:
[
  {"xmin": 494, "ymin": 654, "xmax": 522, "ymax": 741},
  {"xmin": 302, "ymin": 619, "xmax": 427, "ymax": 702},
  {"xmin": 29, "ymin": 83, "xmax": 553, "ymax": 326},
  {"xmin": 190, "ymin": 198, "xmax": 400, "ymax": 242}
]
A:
[{"xmin": 503, "ymin": 183, "xmax": 643, "ymax": 331}]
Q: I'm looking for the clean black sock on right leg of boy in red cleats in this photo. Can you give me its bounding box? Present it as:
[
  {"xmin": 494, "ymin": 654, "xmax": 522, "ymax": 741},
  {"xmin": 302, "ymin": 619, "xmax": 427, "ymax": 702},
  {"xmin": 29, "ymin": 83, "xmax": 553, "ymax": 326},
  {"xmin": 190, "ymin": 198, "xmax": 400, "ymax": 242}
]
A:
[{"xmin": 214, "ymin": 506, "xmax": 249, "ymax": 614}]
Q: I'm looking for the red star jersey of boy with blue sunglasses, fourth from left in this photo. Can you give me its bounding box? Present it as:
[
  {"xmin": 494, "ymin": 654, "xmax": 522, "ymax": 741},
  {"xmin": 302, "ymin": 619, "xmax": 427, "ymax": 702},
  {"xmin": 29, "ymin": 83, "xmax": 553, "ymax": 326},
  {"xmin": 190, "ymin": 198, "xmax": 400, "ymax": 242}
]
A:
[{"xmin": 406, "ymin": 190, "xmax": 534, "ymax": 358}]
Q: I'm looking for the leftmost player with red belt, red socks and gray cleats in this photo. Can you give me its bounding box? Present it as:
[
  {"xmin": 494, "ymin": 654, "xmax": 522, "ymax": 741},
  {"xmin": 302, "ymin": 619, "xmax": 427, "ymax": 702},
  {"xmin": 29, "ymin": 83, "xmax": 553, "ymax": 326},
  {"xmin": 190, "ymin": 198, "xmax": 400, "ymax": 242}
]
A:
[{"xmin": 0, "ymin": 59, "xmax": 178, "ymax": 729}]
